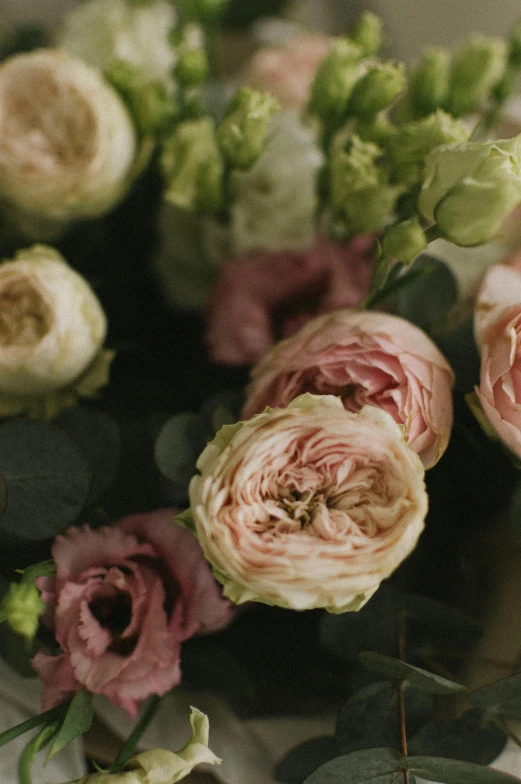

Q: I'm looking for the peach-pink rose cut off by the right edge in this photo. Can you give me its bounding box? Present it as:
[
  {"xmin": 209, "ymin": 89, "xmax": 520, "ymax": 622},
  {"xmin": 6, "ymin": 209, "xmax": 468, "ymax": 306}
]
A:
[{"xmin": 474, "ymin": 260, "xmax": 521, "ymax": 457}]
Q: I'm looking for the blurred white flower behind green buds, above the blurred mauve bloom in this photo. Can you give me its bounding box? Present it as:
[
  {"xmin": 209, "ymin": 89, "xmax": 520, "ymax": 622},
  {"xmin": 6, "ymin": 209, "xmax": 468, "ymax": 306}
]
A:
[{"xmin": 231, "ymin": 112, "xmax": 321, "ymax": 255}]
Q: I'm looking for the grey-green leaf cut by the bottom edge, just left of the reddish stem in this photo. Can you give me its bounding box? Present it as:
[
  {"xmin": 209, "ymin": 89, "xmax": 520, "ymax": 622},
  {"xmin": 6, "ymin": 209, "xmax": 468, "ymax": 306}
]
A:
[{"xmin": 304, "ymin": 748, "xmax": 408, "ymax": 784}]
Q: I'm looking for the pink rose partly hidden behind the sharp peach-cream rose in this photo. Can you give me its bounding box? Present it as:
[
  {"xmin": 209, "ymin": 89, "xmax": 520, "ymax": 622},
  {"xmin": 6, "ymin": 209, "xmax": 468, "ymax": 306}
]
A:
[{"xmin": 243, "ymin": 310, "xmax": 454, "ymax": 468}]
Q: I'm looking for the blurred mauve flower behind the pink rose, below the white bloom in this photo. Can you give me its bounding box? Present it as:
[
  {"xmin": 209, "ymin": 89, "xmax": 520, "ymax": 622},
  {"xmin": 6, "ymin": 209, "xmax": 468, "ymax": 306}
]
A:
[{"xmin": 206, "ymin": 236, "xmax": 375, "ymax": 365}]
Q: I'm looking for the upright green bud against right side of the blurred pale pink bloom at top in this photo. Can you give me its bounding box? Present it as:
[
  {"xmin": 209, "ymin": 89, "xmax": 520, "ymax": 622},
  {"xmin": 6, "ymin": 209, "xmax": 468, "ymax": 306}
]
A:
[{"xmin": 309, "ymin": 38, "xmax": 363, "ymax": 130}]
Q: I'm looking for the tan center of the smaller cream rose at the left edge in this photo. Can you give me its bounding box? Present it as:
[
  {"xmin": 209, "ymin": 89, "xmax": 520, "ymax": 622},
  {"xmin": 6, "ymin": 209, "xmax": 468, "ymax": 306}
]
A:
[{"xmin": 0, "ymin": 276, "xmax": 52, "ymax": 348}]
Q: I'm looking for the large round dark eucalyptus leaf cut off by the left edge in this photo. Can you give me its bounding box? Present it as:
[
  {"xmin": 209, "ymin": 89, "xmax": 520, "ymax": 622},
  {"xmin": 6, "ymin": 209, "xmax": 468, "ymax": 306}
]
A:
[{"xmin": 0, "ymin": 420, "xmax": 90, "ymax": 540}]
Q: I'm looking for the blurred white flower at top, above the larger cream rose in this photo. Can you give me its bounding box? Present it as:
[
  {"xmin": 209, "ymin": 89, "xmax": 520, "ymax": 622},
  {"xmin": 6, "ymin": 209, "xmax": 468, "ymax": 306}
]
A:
[{"xmin": 58, "ymin": 0, "xmax": 176, "ymax": 87}]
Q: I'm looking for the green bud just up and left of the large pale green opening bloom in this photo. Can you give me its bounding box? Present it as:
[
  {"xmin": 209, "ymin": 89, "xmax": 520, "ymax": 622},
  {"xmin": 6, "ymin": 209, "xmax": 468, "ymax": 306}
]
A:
[{"xmin": 388, "ymin": 110, "xmax": 470, "ymax": 183}]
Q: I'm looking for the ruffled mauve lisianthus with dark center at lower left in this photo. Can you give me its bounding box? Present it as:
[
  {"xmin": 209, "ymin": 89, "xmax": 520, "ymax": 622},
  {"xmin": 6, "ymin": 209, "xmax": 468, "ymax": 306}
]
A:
[{"xmin": 33, "ymin": 509, "xmax": 230, "ymax": 716}]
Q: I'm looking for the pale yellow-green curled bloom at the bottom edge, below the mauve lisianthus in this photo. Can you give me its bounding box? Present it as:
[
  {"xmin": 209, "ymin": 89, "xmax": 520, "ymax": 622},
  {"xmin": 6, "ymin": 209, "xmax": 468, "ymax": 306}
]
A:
[{"xmin": 79, "ymin": 708, "xmax": 222, "ymax": 784}]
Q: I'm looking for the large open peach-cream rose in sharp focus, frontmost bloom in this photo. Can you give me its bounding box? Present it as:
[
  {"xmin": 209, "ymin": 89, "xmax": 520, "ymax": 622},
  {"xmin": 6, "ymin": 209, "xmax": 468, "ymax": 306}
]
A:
[{"xmin": 190, "ymin": 394, "xmax": 427, "ymax": 612}]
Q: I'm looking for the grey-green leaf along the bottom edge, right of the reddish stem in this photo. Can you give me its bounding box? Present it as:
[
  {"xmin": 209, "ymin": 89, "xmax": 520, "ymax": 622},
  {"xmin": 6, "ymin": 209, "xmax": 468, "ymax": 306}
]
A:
[{"xmin": 401, "ymin": 757, "xmax": 521, "ymax": 784}]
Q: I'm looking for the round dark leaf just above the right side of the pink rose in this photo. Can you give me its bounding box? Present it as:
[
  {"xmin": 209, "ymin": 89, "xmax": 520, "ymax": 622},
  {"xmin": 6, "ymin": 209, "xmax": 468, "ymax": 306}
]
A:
[{"xmin": 396, "ymin": 254, "xmax": 459, "ymax": 330}]
